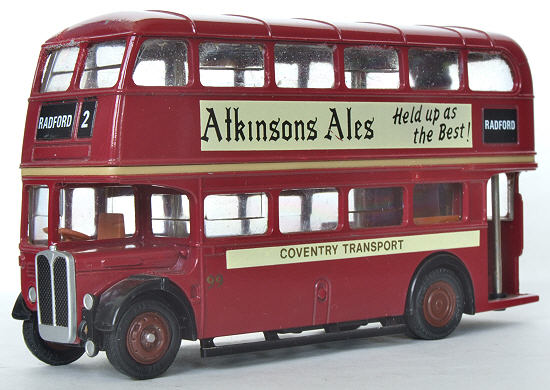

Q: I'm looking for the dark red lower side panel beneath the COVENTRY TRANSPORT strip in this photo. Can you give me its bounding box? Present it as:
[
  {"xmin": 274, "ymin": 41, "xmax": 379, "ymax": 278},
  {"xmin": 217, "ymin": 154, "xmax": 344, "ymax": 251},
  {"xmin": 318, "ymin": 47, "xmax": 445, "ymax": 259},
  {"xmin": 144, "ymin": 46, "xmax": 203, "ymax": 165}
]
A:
[{"xmin": 204, "ymin": 231, "xmax": 487, "ymax": 337}]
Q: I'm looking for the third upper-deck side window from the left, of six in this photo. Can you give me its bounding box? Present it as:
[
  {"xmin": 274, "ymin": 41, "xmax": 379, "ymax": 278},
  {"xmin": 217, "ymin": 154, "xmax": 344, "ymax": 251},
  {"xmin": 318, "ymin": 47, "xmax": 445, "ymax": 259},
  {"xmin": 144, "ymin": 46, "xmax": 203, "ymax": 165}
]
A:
[{"xmin": 275, "ymin": 44, "xmax": 334, "ymax": 88}]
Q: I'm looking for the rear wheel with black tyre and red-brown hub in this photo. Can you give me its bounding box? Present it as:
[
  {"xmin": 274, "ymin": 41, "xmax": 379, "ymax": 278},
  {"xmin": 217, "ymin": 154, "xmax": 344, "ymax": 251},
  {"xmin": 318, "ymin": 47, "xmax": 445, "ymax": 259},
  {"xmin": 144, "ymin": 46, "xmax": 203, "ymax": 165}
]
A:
[{"xmin": 405, "ymin": 268, "xmax": 464, "ymax": 340}]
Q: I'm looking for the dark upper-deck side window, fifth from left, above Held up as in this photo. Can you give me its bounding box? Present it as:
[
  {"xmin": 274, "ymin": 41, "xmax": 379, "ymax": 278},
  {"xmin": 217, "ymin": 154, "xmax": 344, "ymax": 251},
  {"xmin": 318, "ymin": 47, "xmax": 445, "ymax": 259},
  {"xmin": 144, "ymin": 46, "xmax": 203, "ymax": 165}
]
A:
[{"xmin": 409, "ymin": 49, "xmax": 460, "ymax": 90}]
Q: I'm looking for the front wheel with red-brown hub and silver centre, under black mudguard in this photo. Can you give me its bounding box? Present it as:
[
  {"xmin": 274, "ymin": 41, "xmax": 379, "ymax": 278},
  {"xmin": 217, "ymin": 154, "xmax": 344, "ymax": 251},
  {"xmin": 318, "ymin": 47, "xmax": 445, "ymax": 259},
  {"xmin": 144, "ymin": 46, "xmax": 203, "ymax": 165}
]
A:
[{"xmin": 105, "ymin": 300, "xmax": 181, "ymax": 379}]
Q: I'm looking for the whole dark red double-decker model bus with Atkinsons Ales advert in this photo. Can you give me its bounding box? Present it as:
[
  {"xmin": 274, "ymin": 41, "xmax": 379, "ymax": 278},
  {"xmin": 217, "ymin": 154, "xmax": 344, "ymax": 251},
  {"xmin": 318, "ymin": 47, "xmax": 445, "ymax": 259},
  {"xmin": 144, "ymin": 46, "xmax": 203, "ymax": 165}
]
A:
[{"xmin": 13, "ymin": 11, "xmax": 538, "ymax": 378}]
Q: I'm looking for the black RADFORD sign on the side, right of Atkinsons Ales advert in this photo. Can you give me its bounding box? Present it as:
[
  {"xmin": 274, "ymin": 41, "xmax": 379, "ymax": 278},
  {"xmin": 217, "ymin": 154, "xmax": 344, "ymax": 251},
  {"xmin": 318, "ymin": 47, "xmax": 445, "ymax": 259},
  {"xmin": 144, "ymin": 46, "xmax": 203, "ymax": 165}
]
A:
[{"xmin": 483, "ymin": 108, "xmax": 518, "ymax": 144}]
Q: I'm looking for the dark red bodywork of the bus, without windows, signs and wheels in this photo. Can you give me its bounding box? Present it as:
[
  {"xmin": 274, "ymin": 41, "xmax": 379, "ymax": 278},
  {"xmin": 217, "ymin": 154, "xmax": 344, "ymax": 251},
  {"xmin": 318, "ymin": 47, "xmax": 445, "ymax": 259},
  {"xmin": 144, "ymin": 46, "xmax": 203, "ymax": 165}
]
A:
[{"xmin": 16, "ymin": 12, "xmax": 537, "ymax": 338}]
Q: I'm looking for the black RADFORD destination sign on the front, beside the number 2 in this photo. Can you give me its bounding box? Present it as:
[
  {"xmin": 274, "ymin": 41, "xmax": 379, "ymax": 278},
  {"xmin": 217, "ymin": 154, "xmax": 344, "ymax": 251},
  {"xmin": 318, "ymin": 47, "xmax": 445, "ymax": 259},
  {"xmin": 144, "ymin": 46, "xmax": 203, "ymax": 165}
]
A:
[{"xmin": 36, "ymin": 102, "xmax": 76, "ymax": 140}]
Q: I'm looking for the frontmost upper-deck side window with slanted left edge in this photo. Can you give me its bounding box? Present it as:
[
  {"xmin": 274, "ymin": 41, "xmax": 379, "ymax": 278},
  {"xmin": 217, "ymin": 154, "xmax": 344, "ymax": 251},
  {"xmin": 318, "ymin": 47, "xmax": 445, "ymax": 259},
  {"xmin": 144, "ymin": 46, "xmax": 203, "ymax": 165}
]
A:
[{"xmin": 133, "ymin": 39, "xmax": 188, "ymax": 87}]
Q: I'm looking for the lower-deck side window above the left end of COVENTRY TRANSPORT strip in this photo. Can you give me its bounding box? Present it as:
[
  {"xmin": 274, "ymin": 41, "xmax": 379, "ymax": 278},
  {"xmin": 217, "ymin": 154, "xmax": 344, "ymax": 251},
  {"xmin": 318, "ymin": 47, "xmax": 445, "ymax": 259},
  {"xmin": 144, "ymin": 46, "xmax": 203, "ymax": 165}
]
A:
[{"xmin": 204, "ymin": 192, "xmax": 267, "ymax": 237}]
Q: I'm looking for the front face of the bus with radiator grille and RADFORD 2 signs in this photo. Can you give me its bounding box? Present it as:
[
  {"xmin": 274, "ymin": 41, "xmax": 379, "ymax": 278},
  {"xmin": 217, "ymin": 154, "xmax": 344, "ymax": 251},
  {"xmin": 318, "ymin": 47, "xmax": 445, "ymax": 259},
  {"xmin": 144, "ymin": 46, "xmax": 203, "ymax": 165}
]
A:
[{"xmin": 13, "ymin": 32, "xmax": 134, "ymax": 358}]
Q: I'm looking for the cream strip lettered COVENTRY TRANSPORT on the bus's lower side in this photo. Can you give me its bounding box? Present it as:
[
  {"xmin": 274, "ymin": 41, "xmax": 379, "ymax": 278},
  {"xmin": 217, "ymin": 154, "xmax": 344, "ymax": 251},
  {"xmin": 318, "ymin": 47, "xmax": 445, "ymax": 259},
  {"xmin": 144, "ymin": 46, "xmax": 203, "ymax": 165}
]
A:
[{"xmin": 226, "ymin": 230, "xmax": 480, "ymax": 269}]
